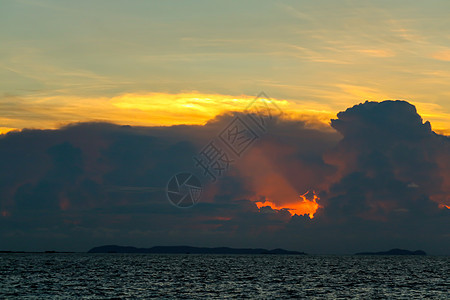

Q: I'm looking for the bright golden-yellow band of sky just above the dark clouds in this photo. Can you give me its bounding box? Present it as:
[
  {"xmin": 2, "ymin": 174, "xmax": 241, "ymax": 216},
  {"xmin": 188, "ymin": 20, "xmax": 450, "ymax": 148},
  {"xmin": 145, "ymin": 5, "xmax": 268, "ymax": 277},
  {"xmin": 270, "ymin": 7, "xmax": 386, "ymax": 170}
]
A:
[{"xmin": 0, "ymin": 92, "xmax": 450, "ymax": 134}]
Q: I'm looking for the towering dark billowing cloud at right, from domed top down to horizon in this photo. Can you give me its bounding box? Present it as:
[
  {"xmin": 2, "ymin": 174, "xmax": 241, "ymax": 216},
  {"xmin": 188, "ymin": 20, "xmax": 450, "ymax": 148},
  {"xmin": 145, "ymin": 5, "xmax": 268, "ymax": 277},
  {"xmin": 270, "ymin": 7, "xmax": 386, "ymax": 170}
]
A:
[{"xmin": 306, "ymin": 101, "xmax": 450, "ymax": 253}]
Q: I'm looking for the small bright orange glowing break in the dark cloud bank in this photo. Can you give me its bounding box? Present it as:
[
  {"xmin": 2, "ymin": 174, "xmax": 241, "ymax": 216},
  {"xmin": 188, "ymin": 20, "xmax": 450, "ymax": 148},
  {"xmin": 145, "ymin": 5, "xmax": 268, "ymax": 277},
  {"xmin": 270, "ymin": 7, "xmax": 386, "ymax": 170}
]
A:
[{"xmin": 255, "ymin": 191, "xmax": 319, "ymax": 219}]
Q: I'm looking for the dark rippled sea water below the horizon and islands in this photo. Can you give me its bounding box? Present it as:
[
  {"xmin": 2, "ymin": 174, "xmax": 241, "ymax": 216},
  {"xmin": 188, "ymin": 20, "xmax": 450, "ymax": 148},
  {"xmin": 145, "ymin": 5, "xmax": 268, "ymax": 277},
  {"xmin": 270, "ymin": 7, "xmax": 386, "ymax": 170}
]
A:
[{"xmin": 0, "ymin": 254, "xmax": 450, "ymax": 299}]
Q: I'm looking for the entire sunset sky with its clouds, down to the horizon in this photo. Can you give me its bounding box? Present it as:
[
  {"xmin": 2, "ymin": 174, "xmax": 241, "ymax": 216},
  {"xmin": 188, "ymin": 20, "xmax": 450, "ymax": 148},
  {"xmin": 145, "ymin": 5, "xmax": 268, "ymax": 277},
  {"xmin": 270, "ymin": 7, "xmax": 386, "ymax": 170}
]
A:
[{"xmin": 0, "ymin": 0, "xmax": 450, "ymax": 254}]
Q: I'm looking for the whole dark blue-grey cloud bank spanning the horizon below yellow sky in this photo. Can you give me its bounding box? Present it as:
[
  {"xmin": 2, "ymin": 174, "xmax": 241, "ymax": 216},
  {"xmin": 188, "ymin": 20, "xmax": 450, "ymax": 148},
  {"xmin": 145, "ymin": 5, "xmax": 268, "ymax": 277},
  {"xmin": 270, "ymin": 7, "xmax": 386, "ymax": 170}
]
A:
[{"xmin": 0, "ymin": 101, "xmax": 450, "ymax": 253}]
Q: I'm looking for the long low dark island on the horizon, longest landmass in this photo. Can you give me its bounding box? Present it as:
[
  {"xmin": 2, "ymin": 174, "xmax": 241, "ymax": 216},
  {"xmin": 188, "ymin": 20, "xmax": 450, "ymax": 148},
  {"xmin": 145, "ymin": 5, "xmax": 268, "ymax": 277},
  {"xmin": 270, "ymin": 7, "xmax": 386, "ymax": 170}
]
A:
[{"xmin": 88, "ymin": 245, "xmax": 306, "ymax": 255}]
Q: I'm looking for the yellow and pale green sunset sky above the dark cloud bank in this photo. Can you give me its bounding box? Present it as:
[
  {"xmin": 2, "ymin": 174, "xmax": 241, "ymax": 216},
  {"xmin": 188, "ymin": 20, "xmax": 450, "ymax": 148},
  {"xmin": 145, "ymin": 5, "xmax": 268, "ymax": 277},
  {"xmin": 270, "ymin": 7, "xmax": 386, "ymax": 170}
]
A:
[{"xmin": 0, "ymin": 0, "xmax": 450, "ymax": 131}]
